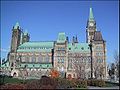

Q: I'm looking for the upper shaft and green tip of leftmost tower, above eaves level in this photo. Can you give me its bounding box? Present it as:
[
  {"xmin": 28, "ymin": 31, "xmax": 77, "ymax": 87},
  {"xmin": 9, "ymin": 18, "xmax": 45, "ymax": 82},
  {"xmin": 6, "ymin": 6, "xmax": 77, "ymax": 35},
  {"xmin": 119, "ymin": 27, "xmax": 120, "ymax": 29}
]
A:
[{"xmin": 11, "ymin": 22, "xmax": 21, "ymax": 52}]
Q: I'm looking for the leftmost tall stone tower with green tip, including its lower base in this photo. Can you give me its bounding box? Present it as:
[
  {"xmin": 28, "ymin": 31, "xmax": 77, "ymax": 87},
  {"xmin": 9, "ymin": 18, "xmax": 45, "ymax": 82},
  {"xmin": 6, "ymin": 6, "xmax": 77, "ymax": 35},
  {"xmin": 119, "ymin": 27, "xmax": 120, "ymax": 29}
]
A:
[{"xmin": 8, "ymin": 22, "xmax": 21, "ymax": 70}]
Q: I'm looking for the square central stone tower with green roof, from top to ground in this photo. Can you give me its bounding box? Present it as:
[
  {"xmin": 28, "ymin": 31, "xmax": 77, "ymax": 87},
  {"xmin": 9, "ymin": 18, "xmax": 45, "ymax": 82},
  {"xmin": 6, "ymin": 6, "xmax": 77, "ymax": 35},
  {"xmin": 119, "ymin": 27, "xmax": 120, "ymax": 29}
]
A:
[{"xmin": 54, "ymin": 32, "xmax": 68, "ymax": 77}]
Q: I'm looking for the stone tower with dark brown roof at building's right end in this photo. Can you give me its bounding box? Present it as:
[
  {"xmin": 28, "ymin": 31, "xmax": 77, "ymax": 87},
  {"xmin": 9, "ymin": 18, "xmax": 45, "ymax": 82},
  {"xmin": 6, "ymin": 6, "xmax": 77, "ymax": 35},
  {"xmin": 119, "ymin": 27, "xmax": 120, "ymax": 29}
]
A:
[{"xmin": 92, "ymin": 31, "xmax": 107, "ymax": 79}]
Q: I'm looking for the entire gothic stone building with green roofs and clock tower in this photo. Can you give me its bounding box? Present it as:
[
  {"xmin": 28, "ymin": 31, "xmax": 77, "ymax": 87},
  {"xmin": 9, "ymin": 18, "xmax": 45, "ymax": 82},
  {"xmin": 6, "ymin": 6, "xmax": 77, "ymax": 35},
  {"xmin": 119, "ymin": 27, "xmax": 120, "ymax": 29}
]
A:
[{"xmin": 0, "ymin": 8, "xmax": 107, "ymax": 79}]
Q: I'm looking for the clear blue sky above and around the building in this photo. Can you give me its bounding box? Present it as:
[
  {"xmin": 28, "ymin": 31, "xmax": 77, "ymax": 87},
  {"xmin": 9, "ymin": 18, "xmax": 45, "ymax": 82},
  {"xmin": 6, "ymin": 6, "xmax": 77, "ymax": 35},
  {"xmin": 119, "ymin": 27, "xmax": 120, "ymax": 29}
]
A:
[{"xmin": 1, "ymin": 1, "xmax": 119, "ymax": 63}]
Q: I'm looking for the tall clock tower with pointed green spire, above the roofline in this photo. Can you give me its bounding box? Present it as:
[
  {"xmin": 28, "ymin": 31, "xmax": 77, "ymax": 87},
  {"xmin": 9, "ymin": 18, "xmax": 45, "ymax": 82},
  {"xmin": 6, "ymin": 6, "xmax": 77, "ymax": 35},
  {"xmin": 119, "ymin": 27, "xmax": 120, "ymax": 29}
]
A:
[{"xmin": 86, "ymin": 8, "xmax": 96, "ymax": 43}]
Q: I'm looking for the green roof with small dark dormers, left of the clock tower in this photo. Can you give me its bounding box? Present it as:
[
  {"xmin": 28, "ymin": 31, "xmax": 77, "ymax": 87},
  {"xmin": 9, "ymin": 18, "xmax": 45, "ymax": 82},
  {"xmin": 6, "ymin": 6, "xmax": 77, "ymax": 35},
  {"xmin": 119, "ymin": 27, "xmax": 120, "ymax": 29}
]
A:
[{"xmin": 67, "ymin": 43, "xmax": 90, "ymax": 52}]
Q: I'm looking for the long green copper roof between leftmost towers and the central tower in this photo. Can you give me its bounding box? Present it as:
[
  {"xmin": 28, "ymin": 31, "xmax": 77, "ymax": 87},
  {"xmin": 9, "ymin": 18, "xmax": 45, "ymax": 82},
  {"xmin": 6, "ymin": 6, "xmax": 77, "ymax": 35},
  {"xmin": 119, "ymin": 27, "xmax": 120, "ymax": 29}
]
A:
[{"xmin": 17, "ymin": 41, "xmax": 54, "ymax": 52}]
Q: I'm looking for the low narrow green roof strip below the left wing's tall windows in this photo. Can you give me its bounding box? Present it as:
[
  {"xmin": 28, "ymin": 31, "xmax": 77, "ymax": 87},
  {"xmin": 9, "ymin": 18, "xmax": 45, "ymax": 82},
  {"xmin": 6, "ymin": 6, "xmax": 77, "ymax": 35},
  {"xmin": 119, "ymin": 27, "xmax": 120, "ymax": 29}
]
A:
[{"xmin": 20, "ymin": 63, "xmax": 52, "ymax": 69}]
